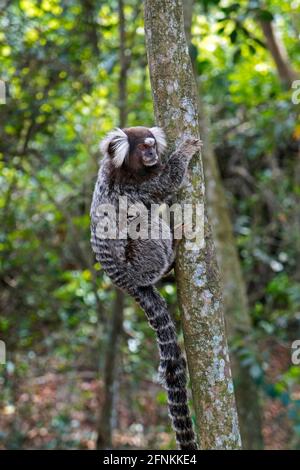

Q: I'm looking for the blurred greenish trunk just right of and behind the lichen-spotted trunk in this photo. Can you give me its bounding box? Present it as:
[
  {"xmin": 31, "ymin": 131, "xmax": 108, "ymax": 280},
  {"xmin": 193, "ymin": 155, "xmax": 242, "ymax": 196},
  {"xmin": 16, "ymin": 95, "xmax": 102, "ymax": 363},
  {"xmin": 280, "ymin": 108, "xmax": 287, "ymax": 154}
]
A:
[{"xmin": 183, "ymin": 0, "xmax": 263, "ymax": 450}]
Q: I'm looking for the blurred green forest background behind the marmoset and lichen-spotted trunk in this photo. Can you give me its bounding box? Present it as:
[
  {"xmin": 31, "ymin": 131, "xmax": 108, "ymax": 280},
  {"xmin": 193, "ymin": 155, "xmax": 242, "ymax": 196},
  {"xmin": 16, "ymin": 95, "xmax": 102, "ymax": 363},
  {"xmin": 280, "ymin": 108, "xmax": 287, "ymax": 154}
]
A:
[{"xmin": 0, "ymin": 0, "xmax": 300, "ymax": 449}]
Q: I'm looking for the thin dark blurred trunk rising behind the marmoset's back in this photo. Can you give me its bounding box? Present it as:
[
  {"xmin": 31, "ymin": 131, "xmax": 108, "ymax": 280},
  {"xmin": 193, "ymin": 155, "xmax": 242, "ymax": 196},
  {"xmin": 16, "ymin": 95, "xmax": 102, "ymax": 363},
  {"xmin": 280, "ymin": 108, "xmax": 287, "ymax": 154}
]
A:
[{"xmin": 97, "ymin": 0, "xmax": 129, "ymax": 449}]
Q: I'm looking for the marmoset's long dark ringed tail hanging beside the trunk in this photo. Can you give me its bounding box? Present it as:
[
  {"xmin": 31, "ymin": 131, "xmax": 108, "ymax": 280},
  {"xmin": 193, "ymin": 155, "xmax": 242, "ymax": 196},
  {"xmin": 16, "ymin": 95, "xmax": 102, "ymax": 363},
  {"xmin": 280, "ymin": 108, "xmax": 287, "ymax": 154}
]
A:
[{"xmin": 131, "ymin": 286, "xmax": 197, "ymax": 450}]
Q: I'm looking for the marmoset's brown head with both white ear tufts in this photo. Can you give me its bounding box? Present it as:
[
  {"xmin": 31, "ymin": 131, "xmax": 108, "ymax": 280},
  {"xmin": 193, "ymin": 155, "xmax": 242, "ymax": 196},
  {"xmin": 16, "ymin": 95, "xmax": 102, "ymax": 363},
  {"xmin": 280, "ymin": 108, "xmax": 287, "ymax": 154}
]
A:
[{"xmin": 100, "ymin": 126, "xmax": 166, "ymax": 178}]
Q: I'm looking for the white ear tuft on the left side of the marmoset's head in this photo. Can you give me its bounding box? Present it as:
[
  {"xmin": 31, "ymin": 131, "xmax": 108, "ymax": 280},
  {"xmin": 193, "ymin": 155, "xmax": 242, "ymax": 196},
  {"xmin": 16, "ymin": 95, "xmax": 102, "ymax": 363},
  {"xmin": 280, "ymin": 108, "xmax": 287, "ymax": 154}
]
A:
[{"xmin": 100, "ymin": 128, "xmax": 129, "ymax": 168}]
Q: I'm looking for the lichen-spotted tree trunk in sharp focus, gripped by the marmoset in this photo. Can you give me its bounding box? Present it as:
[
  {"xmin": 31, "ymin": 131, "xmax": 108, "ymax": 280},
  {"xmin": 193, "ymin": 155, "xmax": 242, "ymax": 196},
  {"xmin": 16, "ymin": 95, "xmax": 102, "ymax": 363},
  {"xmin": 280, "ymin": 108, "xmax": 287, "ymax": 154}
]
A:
[{"xmin": 145, "ymin": 0, "xmax": 241, "ymax": 449}]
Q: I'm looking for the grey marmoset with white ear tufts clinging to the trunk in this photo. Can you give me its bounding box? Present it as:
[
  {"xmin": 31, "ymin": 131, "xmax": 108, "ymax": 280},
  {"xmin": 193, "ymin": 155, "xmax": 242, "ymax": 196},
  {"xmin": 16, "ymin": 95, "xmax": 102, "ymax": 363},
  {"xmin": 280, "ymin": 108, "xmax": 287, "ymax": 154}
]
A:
[{"xmin": 91, "ymin": 127, "xmax": 201, "ymax": 449}]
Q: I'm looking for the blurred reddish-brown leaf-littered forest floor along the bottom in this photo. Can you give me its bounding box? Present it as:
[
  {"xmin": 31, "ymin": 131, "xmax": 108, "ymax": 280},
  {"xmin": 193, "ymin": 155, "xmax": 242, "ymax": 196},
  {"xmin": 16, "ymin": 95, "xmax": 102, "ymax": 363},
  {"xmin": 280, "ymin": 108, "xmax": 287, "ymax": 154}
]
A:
[{"xmin": 0, "ymin": 338, "xmax": 292, "ymax": 449}]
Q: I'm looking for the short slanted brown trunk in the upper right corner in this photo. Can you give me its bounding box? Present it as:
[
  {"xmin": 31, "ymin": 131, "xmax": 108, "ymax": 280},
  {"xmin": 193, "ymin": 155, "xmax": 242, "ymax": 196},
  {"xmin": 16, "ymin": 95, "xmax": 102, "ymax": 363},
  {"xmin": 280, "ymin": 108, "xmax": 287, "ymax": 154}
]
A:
[{"xmin": 260, "ymin": 20, "xmax": 297, "ymax": 87}]
